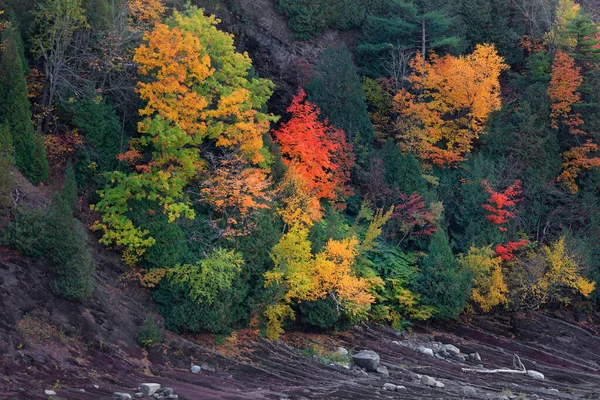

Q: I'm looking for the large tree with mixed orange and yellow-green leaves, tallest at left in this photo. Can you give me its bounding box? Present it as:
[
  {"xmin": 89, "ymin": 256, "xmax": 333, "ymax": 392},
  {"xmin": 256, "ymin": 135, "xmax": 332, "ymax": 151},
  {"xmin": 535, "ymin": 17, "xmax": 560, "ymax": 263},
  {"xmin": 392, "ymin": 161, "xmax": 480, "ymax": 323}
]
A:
[{"xmin": 95, "ymin": 7, "xmax": 272, "ymax": 262}]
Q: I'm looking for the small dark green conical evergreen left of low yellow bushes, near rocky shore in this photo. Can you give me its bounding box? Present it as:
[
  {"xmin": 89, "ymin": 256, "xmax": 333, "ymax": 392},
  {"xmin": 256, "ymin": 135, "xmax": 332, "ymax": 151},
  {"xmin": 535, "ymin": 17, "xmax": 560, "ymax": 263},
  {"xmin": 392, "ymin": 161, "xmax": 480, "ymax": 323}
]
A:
[{"xmin": 415, "ymin": 229, "xmax": 472, "ymax": 319}]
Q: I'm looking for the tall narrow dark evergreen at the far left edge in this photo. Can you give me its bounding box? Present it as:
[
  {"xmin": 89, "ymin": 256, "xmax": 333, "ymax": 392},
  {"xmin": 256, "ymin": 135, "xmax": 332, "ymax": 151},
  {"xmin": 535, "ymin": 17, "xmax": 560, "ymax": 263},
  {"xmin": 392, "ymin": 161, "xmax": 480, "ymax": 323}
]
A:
[{"xmin": 0, "ymin": 26, "xmax": 49, "ymax": 185}]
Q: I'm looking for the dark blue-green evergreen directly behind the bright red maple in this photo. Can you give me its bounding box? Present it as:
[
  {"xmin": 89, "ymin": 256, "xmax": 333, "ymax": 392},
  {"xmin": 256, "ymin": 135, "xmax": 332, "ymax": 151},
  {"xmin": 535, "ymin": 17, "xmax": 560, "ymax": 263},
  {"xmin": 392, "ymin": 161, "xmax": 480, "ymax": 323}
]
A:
[{"xmin": 308, "ymin": 45, "xmax": 374, "ymax": 150}]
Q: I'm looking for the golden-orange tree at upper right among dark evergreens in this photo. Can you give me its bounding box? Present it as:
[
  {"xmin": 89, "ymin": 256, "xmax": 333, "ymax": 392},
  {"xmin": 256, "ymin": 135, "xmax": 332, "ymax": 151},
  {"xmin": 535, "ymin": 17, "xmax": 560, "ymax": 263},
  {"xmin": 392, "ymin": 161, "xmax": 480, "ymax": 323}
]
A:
[{"xmin": 394, "ymin": 45, "xmax": 508, "ymax": 166}]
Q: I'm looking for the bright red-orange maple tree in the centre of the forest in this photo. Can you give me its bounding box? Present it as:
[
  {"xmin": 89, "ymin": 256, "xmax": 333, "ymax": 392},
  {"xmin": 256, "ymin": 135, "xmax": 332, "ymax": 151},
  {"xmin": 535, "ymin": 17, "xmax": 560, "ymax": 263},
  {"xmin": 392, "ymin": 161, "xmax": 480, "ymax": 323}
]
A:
[{"xmin": 275, "ymin": 89, "xmax": 355, "ymax": 201}]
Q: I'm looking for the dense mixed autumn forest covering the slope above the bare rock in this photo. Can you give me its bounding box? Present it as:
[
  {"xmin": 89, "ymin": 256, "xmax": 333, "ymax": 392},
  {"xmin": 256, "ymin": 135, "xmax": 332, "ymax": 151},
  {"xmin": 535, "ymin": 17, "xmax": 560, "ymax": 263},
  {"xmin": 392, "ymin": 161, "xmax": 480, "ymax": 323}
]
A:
[{"xmin": 0, "ymin": 0, "xmax": 600, "ymax": 345}]
